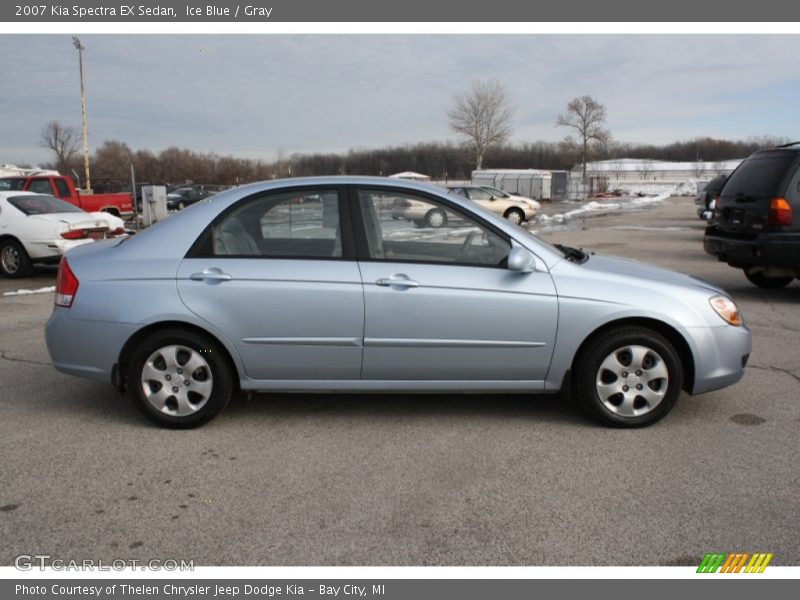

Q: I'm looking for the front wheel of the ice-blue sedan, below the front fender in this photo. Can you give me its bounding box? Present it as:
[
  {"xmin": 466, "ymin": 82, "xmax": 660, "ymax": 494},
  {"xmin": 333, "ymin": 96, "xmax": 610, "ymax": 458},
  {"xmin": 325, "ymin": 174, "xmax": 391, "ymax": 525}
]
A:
[{"xmin": 573, "ymin": 326, "xmax": 683, "ymax": 427}]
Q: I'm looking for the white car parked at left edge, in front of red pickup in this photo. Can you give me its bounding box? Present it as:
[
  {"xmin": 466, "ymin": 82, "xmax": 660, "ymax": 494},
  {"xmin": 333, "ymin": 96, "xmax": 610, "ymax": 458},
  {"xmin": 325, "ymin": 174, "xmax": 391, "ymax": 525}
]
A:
[{"xmin": 0, "ymin": 191, "xmax": 126, "ymax": 277}]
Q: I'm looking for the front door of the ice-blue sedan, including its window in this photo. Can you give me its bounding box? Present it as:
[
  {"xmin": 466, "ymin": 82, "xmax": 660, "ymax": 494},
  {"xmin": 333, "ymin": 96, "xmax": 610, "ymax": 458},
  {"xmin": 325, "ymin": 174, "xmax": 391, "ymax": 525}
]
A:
[{"xmin": 352, "ymin": 188, "xmax": 558, "ymax": 382}]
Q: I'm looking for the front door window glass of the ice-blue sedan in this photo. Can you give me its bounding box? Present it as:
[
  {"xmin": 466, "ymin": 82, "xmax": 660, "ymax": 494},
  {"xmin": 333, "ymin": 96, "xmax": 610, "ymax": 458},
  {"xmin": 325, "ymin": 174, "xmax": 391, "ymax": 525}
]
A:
[{"xmin": 359, "ymin": 190, "xmax": 511, "ymax": 267}]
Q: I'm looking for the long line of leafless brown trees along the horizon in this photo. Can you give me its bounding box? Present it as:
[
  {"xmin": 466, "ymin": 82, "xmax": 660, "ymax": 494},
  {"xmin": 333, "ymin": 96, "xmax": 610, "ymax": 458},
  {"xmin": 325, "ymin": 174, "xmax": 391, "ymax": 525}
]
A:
[{"xmin": 42, "ymin": 122, "xmax": 789, "ymax": 189}]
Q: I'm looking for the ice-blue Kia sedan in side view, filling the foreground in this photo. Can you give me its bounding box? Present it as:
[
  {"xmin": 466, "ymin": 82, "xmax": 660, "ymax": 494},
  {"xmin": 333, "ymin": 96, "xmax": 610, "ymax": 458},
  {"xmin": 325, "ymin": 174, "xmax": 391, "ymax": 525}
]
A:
[{"xmin": 46, "ymin": 177, "xmax": 751, "ymax": 428}]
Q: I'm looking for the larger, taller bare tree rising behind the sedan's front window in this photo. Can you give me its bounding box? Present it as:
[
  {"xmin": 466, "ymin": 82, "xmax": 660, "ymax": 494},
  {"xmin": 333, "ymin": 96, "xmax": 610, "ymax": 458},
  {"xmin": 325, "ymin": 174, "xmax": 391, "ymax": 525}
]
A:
[{"xmin": 447, "ymin": 80, "xmax": 514, "ymax": 169}]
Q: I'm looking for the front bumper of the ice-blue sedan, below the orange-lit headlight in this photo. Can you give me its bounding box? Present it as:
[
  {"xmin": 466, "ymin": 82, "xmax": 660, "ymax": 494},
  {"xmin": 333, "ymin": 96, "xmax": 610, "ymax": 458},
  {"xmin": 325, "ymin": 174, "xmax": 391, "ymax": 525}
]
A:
[{"xmin": 689, "ymin": 325, "xmax": 753, "ymax": 394}]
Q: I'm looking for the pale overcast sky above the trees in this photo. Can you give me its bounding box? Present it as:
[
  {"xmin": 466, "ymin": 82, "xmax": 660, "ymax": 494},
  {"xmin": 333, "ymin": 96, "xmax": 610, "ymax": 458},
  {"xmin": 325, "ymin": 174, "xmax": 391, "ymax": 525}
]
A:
[{"xmin": 0, "ymin": 34, "xmax": 800, "ymax": 166}]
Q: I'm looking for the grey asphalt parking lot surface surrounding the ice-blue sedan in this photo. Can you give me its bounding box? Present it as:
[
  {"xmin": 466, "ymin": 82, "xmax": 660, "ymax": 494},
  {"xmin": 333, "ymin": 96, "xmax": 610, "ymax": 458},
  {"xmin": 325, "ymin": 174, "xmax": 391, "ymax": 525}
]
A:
[{"xmin": 0, "ymin": 198, "xmax": 800, "ymax": 565}]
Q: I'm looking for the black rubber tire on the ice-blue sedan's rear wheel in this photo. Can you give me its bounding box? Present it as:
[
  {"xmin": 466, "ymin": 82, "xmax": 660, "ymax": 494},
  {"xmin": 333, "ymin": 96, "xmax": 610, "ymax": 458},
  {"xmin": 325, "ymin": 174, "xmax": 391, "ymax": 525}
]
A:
[{"xmin": 127, "ymin": 329, "xmax": 234, "ymax": 429}]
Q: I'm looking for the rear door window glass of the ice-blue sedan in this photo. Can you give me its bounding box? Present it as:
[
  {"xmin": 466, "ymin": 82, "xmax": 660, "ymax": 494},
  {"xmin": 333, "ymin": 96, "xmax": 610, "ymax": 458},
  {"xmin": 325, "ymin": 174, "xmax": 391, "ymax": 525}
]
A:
[{"xmin": 213, "ymin": 190, "xmax": 342, "ymax": 258}]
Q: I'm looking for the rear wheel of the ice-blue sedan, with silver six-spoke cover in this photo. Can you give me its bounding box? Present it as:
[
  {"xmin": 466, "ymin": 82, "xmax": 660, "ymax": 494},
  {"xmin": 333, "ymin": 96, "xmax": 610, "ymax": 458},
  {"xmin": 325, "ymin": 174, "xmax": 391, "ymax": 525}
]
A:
[{"xmin": 128, "ymin": 329, "xmax": 233, "ymax": 429}]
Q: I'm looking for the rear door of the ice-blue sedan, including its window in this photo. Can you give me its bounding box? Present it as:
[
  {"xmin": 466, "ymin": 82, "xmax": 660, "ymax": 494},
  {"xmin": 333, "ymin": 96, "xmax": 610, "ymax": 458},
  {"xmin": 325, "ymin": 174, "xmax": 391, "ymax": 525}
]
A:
[{"xmin": 178, "ymin": 186, "xmax": 364, "ymax": 380}]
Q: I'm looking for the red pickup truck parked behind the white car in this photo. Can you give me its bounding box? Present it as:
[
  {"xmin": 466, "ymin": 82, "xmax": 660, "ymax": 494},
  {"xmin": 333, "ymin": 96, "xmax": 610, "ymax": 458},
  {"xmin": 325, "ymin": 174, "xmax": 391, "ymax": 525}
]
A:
[{"xmin": 0, "ymin": 175, "xmax": 133, "ymax": 219}]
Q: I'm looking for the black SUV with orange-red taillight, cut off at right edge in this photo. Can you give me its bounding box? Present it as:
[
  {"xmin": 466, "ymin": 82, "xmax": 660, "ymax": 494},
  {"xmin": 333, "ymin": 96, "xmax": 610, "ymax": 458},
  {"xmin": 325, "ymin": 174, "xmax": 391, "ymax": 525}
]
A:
[{"xmin": 703, "ymin": 142, "xmax": 800, "ymax": 288}]
